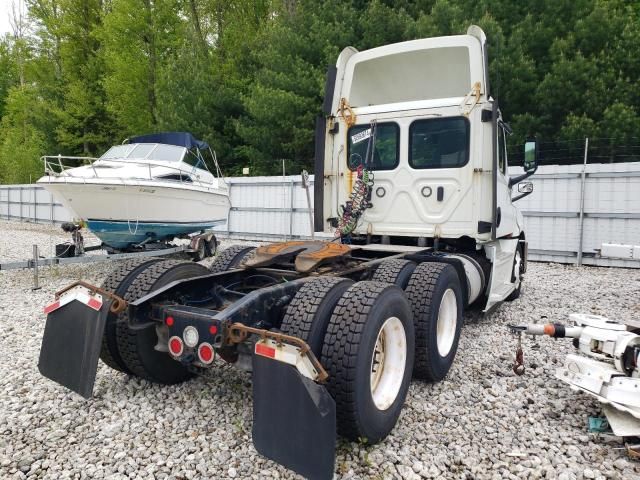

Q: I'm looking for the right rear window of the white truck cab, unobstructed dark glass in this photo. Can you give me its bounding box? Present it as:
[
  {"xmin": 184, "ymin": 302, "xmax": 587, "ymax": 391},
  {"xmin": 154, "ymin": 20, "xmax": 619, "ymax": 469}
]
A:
[{"xmin": 409, "ymin": 117, "xmax": 469, "ymax": 168}]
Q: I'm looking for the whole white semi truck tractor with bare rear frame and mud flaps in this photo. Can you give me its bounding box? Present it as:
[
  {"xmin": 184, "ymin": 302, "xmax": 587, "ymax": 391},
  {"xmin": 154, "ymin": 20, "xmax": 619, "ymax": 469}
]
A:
[{"xmin": 39, "ymin": 26, "xmax": 537, "ymax": 479}]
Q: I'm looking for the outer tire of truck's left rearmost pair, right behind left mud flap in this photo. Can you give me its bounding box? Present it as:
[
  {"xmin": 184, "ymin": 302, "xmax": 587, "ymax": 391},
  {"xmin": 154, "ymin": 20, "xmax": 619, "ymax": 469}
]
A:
[{"xmin": 100, "ymin": 258, "xmax": 160, "ymax": 373}]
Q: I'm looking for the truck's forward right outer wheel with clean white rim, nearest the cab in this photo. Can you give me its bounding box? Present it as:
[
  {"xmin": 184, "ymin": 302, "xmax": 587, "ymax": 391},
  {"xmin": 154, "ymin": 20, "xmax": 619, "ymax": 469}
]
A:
[{"xmin": 405, "ymin": 263, "xmax": 463, "ymax": 382}]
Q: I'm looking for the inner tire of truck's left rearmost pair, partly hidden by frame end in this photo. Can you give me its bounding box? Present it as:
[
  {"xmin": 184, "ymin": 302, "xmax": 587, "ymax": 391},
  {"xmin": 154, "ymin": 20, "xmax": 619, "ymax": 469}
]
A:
[{"xmin": 116, "ymin": 260, "xmax": 209, "ymax": 385}]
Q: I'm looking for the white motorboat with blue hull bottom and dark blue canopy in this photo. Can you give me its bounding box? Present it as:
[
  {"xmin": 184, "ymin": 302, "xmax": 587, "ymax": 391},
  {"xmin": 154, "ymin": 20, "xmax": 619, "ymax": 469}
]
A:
[{"xmin": 37, "ymin": 132, "xmax": 230, "ymax": 250}]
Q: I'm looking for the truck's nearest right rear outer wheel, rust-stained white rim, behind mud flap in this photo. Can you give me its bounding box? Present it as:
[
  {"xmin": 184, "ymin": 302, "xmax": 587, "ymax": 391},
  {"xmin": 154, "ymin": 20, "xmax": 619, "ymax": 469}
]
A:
[{"xmin": 321, "ymin": 281, "xmax": 414, "ymax": 443}]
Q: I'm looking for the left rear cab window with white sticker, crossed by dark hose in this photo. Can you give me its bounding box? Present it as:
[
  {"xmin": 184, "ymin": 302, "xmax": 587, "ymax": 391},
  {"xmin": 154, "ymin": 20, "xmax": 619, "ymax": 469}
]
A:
[{"xmin": 347, "ymin": 122, "xmax": 400, "ymax": 170}]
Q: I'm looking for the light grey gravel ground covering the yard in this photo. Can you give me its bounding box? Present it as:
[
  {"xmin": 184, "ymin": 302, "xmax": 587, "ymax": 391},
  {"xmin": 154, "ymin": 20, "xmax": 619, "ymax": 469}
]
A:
[{"xmin": 0, "ymin": 218, "xmax": 640, "ymax": 480}]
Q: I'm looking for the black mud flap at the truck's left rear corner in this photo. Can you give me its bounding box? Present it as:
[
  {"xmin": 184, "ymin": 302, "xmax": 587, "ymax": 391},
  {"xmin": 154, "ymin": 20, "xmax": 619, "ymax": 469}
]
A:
[{"xmin": 38, "ymin": 300, "xmax": 111, "ymax": 398}]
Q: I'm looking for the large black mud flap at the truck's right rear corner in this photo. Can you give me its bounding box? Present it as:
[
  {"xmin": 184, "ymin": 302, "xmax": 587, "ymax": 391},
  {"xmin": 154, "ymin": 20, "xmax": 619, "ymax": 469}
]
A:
[{"xmin": 253, "ymin": 355, "xmax": 336, "ymax": 480}]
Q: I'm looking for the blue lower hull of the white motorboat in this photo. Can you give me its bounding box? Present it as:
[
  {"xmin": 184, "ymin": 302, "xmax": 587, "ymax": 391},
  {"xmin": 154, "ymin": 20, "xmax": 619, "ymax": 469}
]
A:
[{"xmin": 87, "ymin": 220, "xmax": 226, "ymax": 248}]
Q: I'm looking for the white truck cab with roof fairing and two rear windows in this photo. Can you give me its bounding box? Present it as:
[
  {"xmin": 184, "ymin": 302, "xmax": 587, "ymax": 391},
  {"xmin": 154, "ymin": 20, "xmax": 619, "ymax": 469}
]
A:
[{"xmin": 315, "ymin": 26, "xmax": 535, "ymax": 310}]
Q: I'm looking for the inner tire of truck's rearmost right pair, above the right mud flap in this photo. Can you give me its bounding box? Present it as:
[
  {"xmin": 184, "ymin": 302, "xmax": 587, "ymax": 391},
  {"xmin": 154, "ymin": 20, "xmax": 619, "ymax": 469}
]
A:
[{"xmin": 280, "ymin": 277, "xmax": 353, "ymax": 358}]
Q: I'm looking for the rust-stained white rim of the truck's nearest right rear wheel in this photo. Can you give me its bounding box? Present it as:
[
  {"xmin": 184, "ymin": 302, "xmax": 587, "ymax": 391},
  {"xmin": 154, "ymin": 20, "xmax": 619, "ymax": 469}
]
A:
[{"xmin": 370, "ymin": 317, "xmax": 407, "ymax": 410}]
